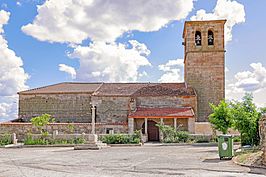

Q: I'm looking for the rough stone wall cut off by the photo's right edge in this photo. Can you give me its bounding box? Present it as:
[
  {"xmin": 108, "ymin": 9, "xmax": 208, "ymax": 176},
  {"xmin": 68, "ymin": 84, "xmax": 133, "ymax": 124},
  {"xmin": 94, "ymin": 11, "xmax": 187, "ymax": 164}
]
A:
[{"xmin": 259, "ymin": 114, "xmax": 266, "ymax": 165}]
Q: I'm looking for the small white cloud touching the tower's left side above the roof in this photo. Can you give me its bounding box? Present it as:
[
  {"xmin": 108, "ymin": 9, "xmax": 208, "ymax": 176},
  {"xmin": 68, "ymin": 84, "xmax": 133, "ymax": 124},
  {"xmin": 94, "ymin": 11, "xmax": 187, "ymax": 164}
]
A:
[{"xmin": 158, "ymin": 59, "xmax": 184, "ymax": 82}]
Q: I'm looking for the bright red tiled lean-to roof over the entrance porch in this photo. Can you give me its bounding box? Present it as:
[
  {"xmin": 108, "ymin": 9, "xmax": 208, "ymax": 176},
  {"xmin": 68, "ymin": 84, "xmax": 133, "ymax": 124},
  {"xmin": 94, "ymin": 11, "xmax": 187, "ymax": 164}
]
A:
[{"xmin": 128, "ymin": 107, "xmax": 194, "ymax": 118}]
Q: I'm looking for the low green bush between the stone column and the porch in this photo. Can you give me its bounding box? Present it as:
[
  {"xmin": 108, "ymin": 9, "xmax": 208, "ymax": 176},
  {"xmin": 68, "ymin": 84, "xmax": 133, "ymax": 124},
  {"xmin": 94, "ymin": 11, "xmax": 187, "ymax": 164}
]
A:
[{"xmin": 101, "ymin": 131, "xmax": 141, "ymax": 144}]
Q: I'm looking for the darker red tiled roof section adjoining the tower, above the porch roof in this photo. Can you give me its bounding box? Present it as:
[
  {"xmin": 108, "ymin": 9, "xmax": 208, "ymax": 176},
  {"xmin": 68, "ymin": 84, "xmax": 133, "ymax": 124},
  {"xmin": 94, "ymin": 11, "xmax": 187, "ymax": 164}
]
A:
[{"xmin": 132, "ymin": 83, "xmax": 196, "ymax": 97}]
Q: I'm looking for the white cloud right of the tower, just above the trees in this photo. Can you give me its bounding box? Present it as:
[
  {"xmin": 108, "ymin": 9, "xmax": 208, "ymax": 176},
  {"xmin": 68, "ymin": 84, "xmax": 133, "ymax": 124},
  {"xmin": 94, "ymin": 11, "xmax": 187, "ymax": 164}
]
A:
[{"xmin": 226, "ymin": 63, "xmax": 266, "ymax": 106}]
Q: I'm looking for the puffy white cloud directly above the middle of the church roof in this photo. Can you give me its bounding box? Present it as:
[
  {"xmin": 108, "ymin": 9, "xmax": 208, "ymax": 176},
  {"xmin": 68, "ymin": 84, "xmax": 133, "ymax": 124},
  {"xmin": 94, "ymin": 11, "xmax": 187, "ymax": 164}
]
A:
[{"xmin": 69, "ymin": 40, "xmax": 151, "ymax": 82}]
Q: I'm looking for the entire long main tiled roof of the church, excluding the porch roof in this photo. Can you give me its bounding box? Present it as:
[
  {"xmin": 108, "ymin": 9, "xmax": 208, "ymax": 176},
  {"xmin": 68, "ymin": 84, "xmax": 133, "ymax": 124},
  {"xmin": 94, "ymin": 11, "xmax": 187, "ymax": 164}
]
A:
[{"xmin": 18, "ymin": 82, "xmax": 196, "ymax": 97}]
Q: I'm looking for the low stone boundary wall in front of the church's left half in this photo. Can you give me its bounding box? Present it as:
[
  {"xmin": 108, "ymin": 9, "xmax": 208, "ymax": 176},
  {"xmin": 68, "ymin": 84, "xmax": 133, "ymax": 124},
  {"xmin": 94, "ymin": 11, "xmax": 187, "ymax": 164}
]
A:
[{"xmin": 0, "ymin": 122, "xmax": 128, "ymax": 141}]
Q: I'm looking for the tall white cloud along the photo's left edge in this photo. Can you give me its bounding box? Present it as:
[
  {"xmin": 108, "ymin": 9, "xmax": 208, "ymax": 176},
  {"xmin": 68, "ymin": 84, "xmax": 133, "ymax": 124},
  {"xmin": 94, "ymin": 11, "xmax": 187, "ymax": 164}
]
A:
[{"xmin": 0, "ymin": 10, "xmax": 29, "ymax": 121}]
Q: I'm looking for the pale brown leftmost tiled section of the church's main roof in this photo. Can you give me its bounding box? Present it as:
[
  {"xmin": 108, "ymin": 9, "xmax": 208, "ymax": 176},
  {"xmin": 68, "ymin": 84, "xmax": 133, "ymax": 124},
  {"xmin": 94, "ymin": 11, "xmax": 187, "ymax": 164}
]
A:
[{"xmin": 18, "ymin": 82, "xmax": 102, "ymax": 94}]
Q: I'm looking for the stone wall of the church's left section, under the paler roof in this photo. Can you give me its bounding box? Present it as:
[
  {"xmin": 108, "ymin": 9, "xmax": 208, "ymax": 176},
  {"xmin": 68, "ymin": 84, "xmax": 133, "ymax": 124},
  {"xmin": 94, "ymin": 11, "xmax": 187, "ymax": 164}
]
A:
[{"xmin": 19, "ymin": 93, "xmax": 91, "ymax": 123}]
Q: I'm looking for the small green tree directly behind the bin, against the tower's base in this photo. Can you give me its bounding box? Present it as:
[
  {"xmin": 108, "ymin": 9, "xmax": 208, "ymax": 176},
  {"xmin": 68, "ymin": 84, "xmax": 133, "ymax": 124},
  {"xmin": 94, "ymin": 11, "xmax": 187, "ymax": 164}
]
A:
[{"xmin": 209, "ymin": 100, "xmax": 232, "ymax": 134}]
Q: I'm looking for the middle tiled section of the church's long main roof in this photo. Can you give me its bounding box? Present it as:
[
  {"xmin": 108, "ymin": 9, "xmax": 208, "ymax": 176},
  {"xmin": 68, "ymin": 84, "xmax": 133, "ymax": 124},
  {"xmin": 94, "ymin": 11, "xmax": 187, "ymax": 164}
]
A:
[{"xmin": 93, "ymin": 83, "xmax": 149, "ymax": 96}]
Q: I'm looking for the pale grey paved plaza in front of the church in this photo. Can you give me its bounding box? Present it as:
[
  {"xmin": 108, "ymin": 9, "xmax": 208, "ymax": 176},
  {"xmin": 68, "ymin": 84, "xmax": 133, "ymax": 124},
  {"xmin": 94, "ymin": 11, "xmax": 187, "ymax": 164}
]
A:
[{"xmin": 0, "ymin": 144, "xmax": 266, "ymax": 177}]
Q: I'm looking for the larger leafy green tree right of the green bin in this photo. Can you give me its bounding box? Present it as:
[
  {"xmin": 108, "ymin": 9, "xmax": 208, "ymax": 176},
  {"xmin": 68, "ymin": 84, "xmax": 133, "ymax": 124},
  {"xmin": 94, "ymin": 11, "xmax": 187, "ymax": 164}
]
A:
[{"xmin": 231, "ymin": 93, "xmax": 261, "ymax": 145}]
